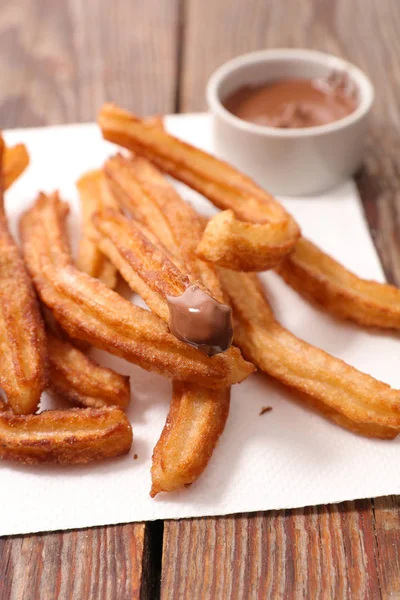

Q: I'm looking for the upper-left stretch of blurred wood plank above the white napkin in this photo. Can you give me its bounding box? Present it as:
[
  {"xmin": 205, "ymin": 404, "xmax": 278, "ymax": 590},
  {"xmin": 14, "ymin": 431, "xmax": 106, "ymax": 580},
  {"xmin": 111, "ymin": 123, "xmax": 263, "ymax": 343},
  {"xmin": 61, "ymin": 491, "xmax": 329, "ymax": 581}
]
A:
[{"xmin": 0, "ymin": 0, "xmax": 178, "ymax": 128}]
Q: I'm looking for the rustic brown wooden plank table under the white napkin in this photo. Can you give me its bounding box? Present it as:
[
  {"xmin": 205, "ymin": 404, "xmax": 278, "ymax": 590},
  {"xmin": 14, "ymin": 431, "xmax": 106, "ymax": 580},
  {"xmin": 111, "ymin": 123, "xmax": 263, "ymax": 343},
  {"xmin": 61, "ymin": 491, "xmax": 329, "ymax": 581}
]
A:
[{"xmin": 0, "ymin": 0, "xmax": 400, "ymax": 600}]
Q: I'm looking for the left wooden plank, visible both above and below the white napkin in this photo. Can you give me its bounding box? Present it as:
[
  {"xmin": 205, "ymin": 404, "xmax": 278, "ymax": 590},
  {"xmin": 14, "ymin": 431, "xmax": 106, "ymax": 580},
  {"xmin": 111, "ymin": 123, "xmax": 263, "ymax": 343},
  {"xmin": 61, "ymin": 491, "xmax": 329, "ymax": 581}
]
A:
[{"xmin": 0, "ymin": 0, "xmax": 178, "ymax": 600}]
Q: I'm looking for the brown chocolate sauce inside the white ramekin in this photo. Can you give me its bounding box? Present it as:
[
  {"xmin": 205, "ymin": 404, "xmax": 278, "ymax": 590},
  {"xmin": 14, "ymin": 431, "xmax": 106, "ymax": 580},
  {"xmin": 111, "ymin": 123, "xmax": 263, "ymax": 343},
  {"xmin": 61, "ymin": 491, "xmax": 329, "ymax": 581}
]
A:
[{"xmin": 224, "ymin": 72, "xmax": 357, "ymax": 128}]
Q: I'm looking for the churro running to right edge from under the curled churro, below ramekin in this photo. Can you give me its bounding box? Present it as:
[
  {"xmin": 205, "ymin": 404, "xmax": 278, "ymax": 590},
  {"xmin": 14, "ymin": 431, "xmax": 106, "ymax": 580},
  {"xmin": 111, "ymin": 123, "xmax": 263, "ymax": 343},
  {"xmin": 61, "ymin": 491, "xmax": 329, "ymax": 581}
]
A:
[{"xmin": 277, "ymin": 238, "xmax": 400, "ymax": 329}]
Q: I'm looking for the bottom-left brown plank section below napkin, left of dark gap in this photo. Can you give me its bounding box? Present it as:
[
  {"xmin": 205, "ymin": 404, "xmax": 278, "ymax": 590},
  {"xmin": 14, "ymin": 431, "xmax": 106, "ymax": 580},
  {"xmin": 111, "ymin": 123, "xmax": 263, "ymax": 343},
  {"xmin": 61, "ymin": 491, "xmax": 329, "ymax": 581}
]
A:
[{"xmin": 0, "ymin": 523, "xmax": 150, "ymax": 600}]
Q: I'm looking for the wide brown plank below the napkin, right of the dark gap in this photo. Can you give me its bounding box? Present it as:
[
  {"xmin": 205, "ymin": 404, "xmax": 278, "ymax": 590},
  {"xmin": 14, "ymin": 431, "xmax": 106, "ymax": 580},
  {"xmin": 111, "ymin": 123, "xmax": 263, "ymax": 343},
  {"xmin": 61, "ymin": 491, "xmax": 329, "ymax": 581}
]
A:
[{"xmin": 161, "ymin": 500, "xmax": 380, "ymax": 600}]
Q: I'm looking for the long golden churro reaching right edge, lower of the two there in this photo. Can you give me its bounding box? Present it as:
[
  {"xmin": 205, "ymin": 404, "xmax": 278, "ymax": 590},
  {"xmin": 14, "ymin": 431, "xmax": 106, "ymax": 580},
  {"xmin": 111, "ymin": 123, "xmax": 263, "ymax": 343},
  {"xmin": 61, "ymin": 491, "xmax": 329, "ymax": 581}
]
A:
[{"xmin": 221, "ymin": 270, "xmax": 400, "ymax": 439}]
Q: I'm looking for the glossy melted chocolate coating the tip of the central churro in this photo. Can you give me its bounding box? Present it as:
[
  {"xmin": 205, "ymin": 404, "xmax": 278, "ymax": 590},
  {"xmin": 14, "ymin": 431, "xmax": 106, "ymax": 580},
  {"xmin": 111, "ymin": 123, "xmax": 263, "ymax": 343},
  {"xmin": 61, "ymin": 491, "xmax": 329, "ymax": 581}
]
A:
[{"xmin": 167, "ymin": 285, "xmax": 233, "ymax": 356}]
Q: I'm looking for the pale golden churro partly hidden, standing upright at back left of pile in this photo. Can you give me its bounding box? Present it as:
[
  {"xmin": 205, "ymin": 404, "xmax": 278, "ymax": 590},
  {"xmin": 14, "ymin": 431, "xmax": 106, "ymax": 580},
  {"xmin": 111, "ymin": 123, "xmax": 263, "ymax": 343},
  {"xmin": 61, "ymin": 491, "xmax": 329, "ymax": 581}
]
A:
[{"xmin": 76, "ymin": 171, "xmax": 118, "ymax": 289}]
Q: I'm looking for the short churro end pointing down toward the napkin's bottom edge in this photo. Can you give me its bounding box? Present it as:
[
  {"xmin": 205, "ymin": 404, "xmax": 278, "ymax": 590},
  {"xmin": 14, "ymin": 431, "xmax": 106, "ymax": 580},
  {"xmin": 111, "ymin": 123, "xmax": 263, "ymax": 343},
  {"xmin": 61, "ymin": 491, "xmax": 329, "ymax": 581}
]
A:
[{"xmin": 150, "ymin": 381, "xmax": 230, "ymax": 497}]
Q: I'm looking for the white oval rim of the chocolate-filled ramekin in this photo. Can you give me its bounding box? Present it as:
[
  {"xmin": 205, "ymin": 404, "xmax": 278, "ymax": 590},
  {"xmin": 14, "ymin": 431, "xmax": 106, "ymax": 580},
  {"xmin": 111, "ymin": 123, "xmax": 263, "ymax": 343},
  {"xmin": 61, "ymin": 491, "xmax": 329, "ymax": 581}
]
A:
[{"xmin": 206, "ymin": 48, "xmax": 375, "ymax": 138}]
